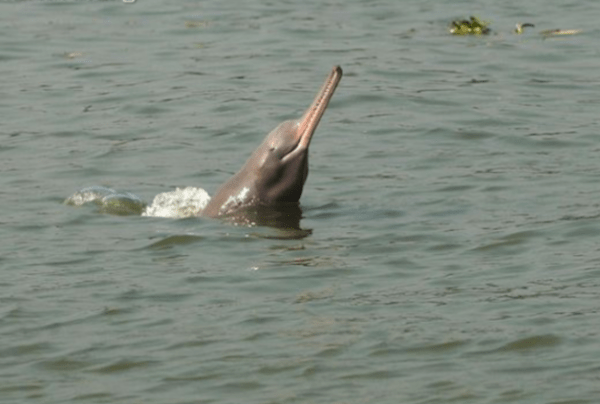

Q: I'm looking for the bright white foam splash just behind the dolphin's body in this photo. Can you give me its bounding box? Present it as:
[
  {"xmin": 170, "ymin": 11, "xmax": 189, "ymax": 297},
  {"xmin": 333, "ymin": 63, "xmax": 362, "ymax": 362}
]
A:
[{"xmin": 142, "ymin": 187, "xmax": 210, "ymax": 218}]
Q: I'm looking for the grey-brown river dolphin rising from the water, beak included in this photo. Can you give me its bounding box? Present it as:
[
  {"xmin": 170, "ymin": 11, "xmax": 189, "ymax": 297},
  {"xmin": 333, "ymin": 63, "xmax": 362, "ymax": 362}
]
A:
[{"xmin": 199, "ymin": 66, "xmax": 342, "ymax": 217}]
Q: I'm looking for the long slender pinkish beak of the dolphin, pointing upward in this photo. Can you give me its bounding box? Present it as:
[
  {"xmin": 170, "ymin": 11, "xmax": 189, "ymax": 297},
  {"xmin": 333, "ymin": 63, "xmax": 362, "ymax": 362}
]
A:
[{"xmin": 297, "ymin": 66, "xmax": 342, "ymax": 149}]
